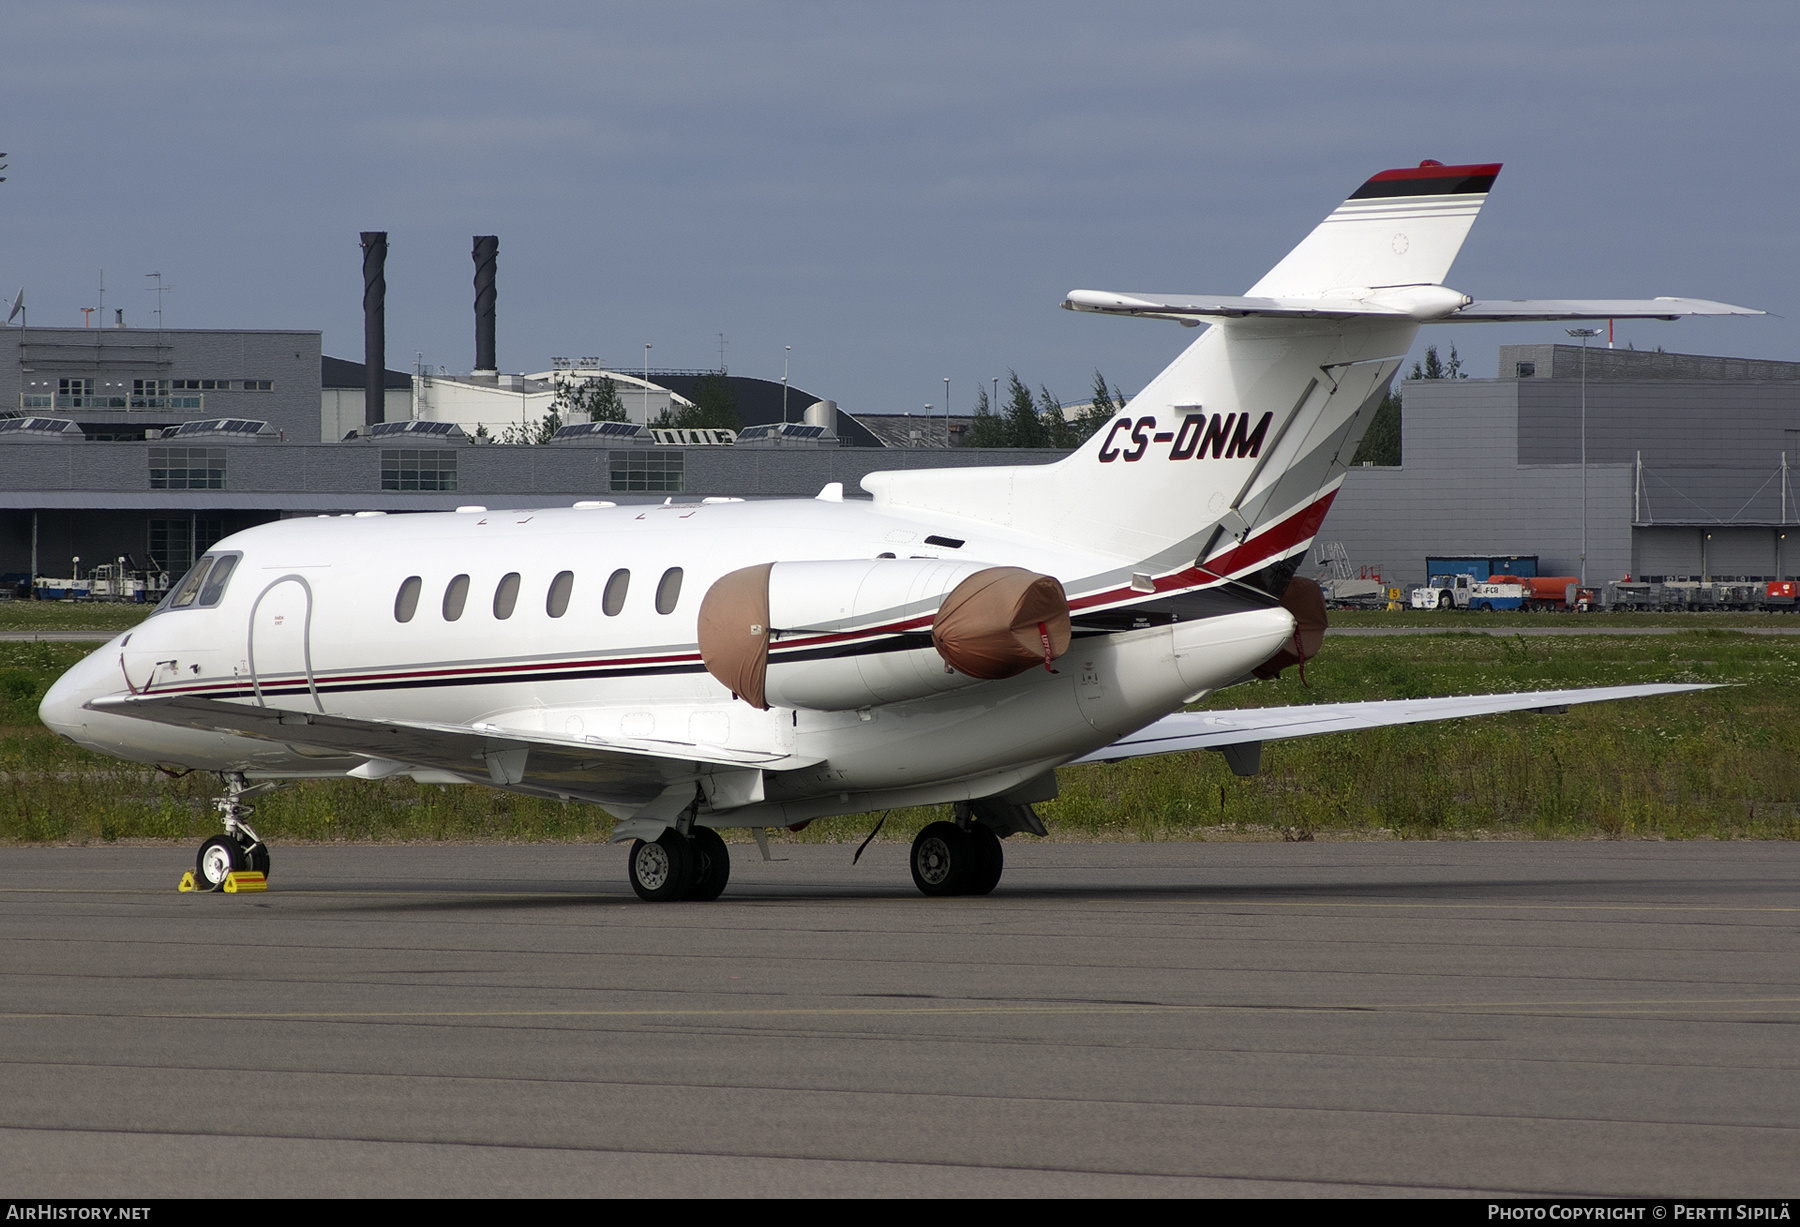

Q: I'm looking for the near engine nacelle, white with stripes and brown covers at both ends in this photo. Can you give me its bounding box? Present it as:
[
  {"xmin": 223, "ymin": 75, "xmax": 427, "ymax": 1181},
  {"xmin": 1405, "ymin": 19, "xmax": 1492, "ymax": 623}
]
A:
[{"xmin": 698, "ymin": 558, "xmax": 1069, "ymax": 711}]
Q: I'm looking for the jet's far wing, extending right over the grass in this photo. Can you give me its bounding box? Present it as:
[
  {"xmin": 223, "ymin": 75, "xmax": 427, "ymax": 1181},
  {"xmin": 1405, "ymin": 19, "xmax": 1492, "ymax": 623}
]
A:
[{"xmin": 1075, "ymin": 684, "xmax": 1714, "ymax": 762}]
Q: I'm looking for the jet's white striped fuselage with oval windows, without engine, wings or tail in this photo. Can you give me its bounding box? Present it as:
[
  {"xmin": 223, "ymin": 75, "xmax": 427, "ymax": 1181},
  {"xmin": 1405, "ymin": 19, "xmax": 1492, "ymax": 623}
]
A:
[{"xmin": 41, "ymin": 498, "xmax": 1292, "ymax": 822}]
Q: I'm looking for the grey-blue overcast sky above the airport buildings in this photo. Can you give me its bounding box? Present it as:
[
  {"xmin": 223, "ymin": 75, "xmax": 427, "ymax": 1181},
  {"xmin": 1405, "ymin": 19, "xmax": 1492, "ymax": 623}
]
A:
[{"xmin": 0, "ymin": 0, "xmax": 1800, "ymax": 412}]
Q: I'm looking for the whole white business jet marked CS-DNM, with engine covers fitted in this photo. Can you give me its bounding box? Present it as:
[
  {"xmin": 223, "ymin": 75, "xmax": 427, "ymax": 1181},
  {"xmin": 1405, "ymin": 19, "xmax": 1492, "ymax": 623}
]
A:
[{"xmin": 41, "ymin": 162, "xmax": 1759, "ymax": 900}]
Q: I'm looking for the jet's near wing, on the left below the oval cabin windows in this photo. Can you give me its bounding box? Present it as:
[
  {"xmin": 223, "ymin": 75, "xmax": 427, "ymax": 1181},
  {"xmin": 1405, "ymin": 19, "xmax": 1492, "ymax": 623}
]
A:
[{"xmin": 90, "ymin": 694, "xmax": 817, "ymax": 804}]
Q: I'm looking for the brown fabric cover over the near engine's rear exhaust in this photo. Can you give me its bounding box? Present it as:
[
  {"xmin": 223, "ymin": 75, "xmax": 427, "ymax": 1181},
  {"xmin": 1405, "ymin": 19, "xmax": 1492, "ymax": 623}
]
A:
[{"xmin": 931, "ymin": 567, "xmax": 1069, "ymax": 680}]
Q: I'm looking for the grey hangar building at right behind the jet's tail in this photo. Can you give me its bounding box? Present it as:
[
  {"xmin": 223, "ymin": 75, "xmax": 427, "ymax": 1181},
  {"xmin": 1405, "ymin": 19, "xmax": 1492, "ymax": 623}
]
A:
[{"xmin": 1324, "ymin": 345, "xmax": 1800, "ymax": 587}]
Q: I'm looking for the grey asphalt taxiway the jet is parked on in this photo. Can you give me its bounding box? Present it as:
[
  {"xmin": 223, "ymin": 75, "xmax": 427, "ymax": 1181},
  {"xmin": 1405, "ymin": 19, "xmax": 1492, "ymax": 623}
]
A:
[{"xmin": 0, "ymin": 838, "xmax": 1800, "ymax": 1196}]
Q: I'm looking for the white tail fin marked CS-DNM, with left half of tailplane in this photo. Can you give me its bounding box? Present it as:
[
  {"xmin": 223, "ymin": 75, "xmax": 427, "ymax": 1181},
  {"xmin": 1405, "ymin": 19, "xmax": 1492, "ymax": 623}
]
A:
[{"xmin": 862, "ymin": 162, "xmax": 1499, "ymax": 592}]
